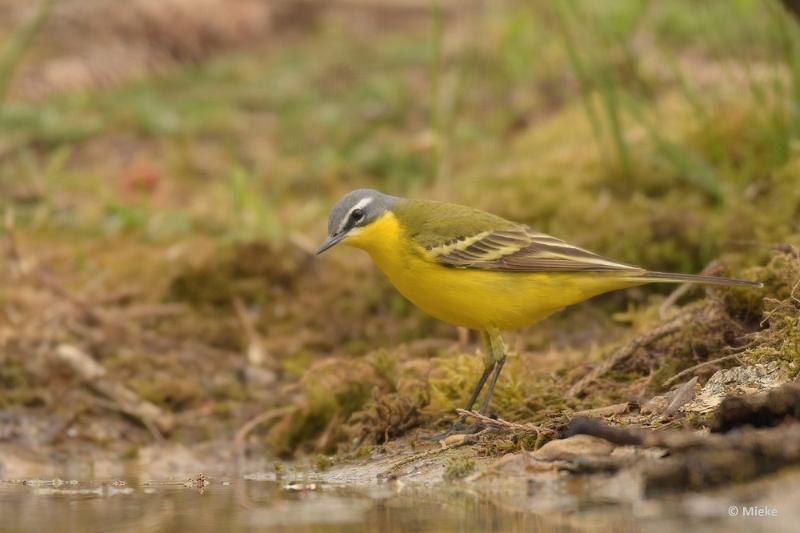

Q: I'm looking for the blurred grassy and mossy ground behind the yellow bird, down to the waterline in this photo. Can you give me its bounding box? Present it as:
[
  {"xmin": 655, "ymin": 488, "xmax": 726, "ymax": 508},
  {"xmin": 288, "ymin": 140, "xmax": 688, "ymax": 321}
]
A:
[{"xmin": 0, "ymin": 0, "xmax": 800, "ymax": 466}]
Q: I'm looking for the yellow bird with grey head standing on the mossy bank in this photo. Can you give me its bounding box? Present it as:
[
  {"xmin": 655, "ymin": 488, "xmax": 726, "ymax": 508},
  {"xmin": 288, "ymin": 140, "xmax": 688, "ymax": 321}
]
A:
[{"xmin": 317, "ymin": 189, "xmax": 761, "ymax": 438}]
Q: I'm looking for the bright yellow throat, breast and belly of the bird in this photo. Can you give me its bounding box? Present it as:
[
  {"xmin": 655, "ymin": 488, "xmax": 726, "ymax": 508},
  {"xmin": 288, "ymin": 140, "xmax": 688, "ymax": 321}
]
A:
[{"xmin": 344, "ymin": 212, "xmax": 641, "ymax": 330}]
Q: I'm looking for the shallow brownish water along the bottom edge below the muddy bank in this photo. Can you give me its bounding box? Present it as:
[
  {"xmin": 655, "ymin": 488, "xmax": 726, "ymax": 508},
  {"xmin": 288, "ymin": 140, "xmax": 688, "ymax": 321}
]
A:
[{"xmin": 0, "ymin": 470, "xmax": 788, "ymax": 533}]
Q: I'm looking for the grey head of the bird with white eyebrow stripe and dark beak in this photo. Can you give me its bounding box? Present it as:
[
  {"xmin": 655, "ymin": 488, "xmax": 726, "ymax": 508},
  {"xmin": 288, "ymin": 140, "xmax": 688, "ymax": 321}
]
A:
[{"xmin": 317, "ymin": 189, "xmax": 397, "ymax": 254}]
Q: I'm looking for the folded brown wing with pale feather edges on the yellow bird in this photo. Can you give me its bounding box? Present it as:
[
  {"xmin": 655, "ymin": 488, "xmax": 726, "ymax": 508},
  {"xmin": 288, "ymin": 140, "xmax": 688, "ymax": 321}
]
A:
[{"xmin": 428, "ymin": 228, "xmax": 644, "ymax": 274}]
